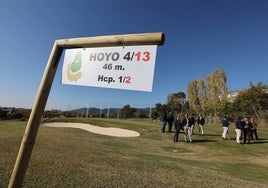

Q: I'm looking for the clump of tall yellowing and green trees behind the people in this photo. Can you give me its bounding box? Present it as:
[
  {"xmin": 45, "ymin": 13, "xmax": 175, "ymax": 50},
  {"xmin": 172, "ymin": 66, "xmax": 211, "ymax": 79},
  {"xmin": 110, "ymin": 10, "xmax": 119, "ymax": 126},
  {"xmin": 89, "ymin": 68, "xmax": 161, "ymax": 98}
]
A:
[{"xmin": 153, "ymin": 69, "xmax": 268, "ymax": 122}]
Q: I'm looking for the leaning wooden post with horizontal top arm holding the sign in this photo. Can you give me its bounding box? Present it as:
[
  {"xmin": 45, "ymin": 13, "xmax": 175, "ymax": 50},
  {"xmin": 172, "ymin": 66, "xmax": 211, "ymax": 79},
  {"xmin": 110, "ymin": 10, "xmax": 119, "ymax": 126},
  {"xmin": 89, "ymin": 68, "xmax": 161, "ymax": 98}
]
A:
[{"xmin": 8, "ymin": 33, "xmax": 165, "ymax": 188}]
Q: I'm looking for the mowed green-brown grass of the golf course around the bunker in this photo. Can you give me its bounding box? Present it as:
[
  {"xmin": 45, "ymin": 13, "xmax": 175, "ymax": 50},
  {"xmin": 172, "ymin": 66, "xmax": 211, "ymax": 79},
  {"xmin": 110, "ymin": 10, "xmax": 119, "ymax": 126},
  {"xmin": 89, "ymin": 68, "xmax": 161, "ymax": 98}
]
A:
[{"xmin": 0, "ymin": 118, "xmax": 268, "ymax": 188}]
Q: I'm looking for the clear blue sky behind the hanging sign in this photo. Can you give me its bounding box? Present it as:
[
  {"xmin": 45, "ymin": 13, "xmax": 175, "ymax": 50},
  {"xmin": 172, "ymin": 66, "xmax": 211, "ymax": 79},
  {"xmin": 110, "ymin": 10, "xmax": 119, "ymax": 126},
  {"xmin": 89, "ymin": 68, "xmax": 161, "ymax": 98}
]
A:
[{"xmin": 0, "ymin": 0, "xmax": 268, "ymax": 110}]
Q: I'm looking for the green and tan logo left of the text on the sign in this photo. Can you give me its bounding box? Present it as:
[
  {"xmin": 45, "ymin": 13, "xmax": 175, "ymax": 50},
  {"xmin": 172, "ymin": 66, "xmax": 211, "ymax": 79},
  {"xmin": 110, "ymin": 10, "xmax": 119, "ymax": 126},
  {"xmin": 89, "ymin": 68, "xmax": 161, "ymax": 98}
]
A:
[{"xmin": 67, "ymin": 52, "xmax": 82, "ymax": 82}]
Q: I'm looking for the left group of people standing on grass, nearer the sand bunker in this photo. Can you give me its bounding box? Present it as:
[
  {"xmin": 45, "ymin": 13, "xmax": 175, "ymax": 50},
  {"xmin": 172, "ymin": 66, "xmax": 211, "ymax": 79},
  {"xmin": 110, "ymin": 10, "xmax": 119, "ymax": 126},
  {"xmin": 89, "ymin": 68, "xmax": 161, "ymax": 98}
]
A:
[{"xmin": 161, "ymin": 112, "xmax": 205, "ymax": 142}]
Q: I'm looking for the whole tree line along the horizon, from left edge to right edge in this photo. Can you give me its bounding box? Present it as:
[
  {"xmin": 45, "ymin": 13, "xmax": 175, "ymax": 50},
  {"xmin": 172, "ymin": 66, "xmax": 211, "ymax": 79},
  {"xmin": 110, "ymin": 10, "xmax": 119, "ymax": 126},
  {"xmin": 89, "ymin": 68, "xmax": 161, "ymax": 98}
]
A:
[{"xmin": 0, "ymin": 69, "xmax": 268, "ymax": 123}]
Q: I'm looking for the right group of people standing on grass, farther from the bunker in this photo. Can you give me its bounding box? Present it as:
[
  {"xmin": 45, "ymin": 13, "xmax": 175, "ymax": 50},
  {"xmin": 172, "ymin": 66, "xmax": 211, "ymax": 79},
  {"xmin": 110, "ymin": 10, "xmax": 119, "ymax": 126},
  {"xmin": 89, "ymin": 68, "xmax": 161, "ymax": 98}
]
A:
[{"xmin": 221, "ymin": 117, "xmax": 259, "ymax": 144}]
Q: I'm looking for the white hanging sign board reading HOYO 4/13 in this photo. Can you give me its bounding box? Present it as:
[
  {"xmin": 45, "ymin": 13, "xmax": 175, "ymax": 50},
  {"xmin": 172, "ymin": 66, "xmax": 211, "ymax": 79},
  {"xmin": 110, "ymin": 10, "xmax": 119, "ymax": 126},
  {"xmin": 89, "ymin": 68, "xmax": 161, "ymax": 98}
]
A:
[{"xmin": 62, "ymin": 45, "xmax": 157, "ymax": 91}]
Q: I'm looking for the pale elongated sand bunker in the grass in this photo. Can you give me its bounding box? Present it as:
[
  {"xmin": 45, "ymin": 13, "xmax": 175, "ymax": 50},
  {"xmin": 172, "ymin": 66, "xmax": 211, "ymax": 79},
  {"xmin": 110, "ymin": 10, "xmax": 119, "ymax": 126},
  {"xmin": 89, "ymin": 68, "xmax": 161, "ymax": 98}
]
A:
[{"xmin": 42, "ymin": 122, "xmax": 140, "ymax": 137}]
